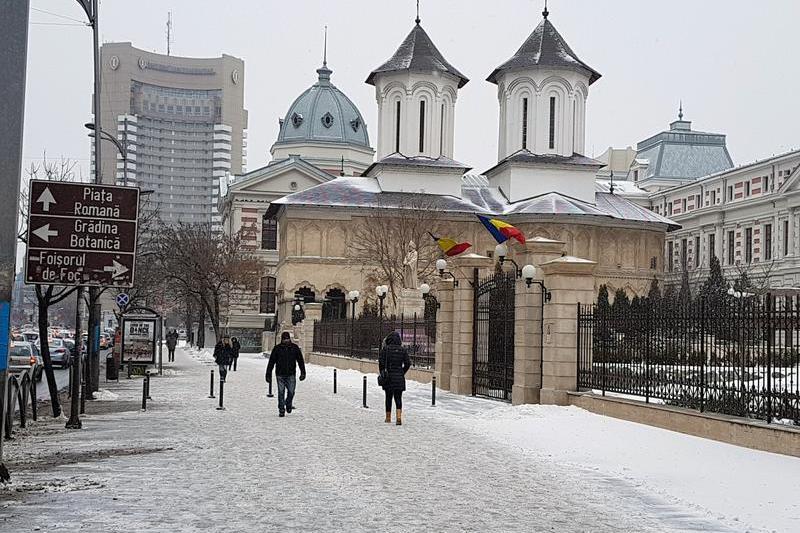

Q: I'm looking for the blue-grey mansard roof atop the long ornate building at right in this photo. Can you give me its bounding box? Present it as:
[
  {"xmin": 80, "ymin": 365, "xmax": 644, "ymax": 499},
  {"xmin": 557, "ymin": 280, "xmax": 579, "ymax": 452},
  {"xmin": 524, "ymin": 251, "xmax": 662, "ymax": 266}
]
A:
[{"xmin": 636, "ymin": 113, "xmax": 733, "ymax": 181}]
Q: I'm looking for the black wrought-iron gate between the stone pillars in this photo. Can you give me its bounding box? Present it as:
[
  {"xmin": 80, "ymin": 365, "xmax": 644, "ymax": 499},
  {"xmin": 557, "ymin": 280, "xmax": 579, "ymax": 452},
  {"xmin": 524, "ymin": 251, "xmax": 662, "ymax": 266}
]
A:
[{"xmin": 472, "ymin": 269, "xmax": 516, "ymax": 402}]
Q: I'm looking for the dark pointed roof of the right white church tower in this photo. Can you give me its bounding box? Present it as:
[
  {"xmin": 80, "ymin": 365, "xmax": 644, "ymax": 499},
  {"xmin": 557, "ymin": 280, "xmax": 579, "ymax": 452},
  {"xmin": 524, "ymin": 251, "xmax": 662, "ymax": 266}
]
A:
[{"xmin": 486, "ymin": 11, "xmax": 601, "ymax": 85}]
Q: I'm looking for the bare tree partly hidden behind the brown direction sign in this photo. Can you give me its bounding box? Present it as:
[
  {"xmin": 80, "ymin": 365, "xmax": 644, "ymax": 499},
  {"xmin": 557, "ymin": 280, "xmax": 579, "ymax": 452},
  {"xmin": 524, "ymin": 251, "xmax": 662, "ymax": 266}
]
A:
[{"xmin": 17, "ymin": 154, "xmax": 80, "ymax": 417}]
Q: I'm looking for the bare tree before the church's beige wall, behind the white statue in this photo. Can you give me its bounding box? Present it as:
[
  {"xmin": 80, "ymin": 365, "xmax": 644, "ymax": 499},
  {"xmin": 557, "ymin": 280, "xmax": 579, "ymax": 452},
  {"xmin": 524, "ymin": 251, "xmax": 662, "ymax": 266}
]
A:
[{"xmin": 352, "ymin": 194, "xmax": 458, "ymax": 305}]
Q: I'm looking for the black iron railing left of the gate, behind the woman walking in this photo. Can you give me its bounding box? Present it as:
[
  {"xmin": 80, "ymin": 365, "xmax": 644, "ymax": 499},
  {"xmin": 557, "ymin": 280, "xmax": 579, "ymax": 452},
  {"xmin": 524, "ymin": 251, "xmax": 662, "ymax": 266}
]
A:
[{"xmin": 313, "ymin": 314, "xmax": 436, "ymax": 368}]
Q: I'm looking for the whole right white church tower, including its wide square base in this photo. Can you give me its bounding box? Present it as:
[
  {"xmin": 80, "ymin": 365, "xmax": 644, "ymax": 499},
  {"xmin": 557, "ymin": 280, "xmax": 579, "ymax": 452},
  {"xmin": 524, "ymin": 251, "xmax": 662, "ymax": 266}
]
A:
[{"xmin": 485, "ymin": 4, "xmax": 603, "ymax": 204}]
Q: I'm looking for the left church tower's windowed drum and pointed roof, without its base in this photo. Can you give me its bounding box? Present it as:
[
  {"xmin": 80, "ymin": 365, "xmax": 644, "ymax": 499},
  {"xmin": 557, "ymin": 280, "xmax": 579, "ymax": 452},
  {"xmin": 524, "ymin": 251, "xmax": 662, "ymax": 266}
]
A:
[{"xmin": 366, "ymin": 15, "xmax": 469, "ymax": 161}]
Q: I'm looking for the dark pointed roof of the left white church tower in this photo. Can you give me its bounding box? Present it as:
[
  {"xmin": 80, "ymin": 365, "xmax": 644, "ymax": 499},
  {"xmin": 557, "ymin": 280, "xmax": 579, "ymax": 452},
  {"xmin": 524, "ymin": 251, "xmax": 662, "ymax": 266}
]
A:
[{"xmin": 367, "ymin": 22, "xmax": 469, "ymax": 89}]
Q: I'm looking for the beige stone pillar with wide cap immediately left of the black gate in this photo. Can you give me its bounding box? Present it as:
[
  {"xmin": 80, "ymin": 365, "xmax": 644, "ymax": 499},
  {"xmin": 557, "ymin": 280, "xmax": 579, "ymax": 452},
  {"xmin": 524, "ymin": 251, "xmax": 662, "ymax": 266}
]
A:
[{"xmin": 450, "ymin": 254, "xmax": 494, "ymax": 395}]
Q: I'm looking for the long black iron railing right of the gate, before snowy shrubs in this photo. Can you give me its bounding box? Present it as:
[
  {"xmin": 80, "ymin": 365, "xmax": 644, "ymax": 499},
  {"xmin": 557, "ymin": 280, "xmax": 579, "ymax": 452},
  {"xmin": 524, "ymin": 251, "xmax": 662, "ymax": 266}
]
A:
[{"xmin": 577, "ymin": 295, "xmax": 800, "ymax": 425}]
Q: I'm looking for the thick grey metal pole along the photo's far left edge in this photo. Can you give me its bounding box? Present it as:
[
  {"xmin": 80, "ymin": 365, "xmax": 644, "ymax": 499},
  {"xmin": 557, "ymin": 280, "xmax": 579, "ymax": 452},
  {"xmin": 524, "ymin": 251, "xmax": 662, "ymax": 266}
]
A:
[{"xmin": 0, "ymin": 0, "xmax": 29, "ymax": 474}]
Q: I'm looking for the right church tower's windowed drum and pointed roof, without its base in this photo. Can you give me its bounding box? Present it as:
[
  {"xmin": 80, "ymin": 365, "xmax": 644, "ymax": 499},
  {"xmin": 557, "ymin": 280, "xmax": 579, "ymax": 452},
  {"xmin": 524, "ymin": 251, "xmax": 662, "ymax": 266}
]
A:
[{"xmin": 487, "ymin": 6, "xmax": 600, "ymax": 160}]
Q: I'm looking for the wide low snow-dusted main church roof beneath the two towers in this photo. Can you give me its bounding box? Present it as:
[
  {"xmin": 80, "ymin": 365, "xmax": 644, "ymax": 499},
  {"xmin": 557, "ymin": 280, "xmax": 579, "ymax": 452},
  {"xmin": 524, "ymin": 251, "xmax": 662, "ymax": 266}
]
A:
[{"xmin": 269, "ymin": 174, "xmax": 680, "ymax": 230}]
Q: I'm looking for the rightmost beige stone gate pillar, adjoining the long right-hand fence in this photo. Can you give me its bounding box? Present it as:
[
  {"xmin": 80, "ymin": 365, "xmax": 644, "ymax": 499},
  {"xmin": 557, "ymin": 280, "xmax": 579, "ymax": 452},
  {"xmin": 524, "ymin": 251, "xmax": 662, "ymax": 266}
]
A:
[{"xmin": 540, "ymin": 256, "xmax": 597, "ymax": 405}]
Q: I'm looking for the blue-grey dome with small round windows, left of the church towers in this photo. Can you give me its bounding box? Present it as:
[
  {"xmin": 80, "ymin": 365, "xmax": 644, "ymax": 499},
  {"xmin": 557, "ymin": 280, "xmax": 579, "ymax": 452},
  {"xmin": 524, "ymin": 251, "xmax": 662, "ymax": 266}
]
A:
[{"xmin": 275, "ymin": 63, "xmax": 369, "ymax": 148}]
